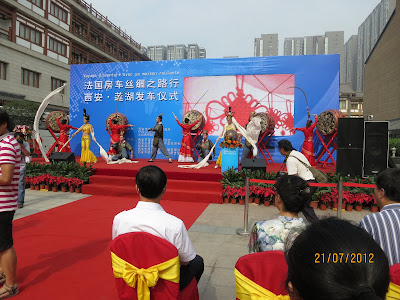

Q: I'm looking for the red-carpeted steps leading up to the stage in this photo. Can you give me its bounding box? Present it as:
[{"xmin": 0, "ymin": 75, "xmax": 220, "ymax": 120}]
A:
[{"xmin": 82, "ymin": 175, "xmax": 222, "ymax": 203}]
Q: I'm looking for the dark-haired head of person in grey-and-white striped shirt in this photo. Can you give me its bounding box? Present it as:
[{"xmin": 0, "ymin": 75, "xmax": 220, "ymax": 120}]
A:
[{"xmin": 374, "ymin": 168, "xmax": 400, "ymax": 207}]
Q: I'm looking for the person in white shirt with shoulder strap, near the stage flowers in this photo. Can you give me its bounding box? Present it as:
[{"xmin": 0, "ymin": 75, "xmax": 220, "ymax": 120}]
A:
[{"xmin": 278, "ymin": 140, "xmax": 319, "ymax": 223}]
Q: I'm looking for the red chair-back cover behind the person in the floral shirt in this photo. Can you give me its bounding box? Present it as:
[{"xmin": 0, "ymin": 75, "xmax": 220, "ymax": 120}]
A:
[{"xmin": 235, "ymin": 251, "xmax": 288, "ymax": 299}]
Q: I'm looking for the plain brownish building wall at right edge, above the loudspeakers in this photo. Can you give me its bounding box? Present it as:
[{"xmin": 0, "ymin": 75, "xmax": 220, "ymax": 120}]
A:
[{"xmin": 364, "ymin": 0, "xmax": 400, "ymax": 121}]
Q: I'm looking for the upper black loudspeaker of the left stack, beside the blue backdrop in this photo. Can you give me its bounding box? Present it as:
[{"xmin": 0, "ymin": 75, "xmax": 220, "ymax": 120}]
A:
[{"xmin": 337, "ymin": 118, "xmax": 364, "ymax": 149}]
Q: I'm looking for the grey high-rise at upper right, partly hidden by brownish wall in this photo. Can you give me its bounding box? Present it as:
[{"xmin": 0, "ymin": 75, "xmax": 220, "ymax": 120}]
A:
[{"xmin": 357, "ymin": 0, "xmax": 396, "ymax": 91}]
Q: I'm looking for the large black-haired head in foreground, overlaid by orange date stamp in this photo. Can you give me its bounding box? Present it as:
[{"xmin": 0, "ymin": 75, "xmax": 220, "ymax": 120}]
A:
[{"xmin": 286, "ymin": 218, "xmax": 390, "ymax": 300}]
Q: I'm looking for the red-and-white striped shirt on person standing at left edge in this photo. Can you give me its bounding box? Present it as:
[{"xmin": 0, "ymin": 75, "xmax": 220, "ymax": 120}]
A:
[{"xmin": 0, "ymin": 135, "xmax": 21, "ymax": 212}]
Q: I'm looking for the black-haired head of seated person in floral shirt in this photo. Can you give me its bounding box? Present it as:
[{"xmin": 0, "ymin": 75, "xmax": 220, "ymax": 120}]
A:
[{"xmin": 275, "ymin": 175, "xmax": 311, "ymax": 213}]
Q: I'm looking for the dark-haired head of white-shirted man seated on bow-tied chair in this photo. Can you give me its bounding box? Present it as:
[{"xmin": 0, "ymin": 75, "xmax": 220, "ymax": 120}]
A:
[{"xmin": 136, "ymin": 166, "xmax": 167, "ymax": 200}]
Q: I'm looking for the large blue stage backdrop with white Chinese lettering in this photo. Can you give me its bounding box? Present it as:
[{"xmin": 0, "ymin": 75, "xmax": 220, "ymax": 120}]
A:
[{"xmin": 70, "ymin": 55, "xmax": 340, "ymax": 162}]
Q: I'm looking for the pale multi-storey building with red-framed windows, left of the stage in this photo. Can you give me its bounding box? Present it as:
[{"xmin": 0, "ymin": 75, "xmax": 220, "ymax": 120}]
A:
[{"xmin": 0, "ymin": 0, "xmax": 149, "ymax": 107}]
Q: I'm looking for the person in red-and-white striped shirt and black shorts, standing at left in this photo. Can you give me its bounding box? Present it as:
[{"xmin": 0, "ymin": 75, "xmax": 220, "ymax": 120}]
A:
[{"xmin": 0, "ymin": 108, "xmax": 21, "ymax": 299}]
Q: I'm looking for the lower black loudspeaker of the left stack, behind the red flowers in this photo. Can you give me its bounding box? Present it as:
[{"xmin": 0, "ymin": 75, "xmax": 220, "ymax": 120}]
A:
[{"xmin": 336, "ymin": 148, "xmax": 363, "ymax": 177}]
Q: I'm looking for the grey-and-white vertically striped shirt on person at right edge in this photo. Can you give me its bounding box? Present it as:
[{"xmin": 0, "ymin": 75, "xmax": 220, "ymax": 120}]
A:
[{"xmin": 358, "ymin": 203, "xmax": 400, "ymax": 265}]
